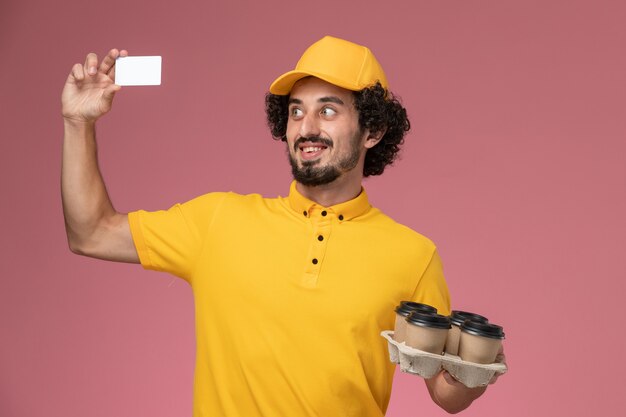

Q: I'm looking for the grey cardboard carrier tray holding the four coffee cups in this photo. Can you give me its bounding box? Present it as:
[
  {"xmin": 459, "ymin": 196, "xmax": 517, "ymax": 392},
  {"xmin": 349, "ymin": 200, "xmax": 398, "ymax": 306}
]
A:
[{"xmin": 380, "ymin": 330, "xmax": 507, "ymax": 388}]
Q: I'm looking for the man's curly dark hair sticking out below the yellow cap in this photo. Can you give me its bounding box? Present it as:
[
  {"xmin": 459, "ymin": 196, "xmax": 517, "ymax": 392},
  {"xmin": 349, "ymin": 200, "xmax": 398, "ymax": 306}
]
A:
[{"xmin": 265, "ymin": 83, "xmax": 411, "ymax": 177}]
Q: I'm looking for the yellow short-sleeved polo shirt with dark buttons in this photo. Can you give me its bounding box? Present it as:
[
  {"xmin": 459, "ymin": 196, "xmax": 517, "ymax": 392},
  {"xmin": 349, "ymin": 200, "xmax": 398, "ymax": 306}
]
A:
[{"xmin": 129, "ymin": 183, "xmax": 450, "ymax": 417}]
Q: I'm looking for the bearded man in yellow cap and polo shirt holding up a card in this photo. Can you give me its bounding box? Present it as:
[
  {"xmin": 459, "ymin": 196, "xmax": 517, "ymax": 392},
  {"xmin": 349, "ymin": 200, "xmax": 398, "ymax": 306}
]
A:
[{"xmin": 62, "ymin": 37, "xmax": 494, "ymax": 417}]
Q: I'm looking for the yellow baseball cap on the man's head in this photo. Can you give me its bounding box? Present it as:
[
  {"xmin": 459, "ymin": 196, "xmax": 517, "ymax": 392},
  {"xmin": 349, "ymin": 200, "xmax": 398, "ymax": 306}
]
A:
[{"xmin": 270, "ymin": 36, "xmax": 388, "ymax": 95}]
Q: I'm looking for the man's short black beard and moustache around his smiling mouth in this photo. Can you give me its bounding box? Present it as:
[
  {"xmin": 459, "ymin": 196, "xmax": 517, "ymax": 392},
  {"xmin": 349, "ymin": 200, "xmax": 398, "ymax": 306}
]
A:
[{"xmin": 287, "ymin": 136, "xmax": 360, "ymax": 187}]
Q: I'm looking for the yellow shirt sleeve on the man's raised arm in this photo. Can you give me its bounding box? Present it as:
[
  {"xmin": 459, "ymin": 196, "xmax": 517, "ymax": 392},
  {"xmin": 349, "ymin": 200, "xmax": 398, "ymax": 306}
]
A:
[{"xmin": 128, "ymin": 193, "xmax": 227, "ymax": 281}]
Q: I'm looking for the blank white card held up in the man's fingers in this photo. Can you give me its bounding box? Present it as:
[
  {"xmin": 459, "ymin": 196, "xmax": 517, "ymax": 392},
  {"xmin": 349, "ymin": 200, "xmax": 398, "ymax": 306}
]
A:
[{"xmin": 115, "ymin": 56, "xmax": 161, "ymax": 85}]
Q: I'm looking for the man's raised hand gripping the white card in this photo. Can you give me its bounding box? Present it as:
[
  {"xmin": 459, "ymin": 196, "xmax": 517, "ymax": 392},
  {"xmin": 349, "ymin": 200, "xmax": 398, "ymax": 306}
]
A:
[{"xmin": 61, "ymin": 49, "xmax": 128, "ymax": 122}]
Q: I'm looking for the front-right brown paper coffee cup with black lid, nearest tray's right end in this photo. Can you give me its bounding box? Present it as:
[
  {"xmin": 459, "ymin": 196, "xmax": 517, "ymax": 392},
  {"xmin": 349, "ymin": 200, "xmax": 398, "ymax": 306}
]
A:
[{"xmin": 459, "ymin": 320, "xmax": 504, "ymax": 364}]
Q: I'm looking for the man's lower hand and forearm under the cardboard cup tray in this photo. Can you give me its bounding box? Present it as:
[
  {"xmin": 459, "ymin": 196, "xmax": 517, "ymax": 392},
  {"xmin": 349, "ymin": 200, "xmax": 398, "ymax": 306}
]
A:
[{"xmin": 426, "ymin": 371, "xmax": 487, "ymax": 414}]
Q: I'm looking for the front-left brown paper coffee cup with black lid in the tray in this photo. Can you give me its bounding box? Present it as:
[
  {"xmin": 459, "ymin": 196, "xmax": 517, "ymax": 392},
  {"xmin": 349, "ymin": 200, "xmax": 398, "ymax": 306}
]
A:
[{"xmin": 405, "ymin": 311, "xmax": 450, "ymax": 355}]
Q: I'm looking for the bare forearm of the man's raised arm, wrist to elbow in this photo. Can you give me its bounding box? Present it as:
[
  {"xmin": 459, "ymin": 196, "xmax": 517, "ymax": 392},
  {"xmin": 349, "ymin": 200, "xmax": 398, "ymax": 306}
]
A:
[{"xmin": 61, "ymin": 119, "xmax": 115, "ymax": 252}]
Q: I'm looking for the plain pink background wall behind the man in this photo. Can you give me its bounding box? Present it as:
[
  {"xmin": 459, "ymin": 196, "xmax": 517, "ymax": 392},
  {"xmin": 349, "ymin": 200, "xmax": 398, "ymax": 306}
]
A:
[{"xmin": 0, "ymin": 0, "xmax": 626, "ymax": 417}]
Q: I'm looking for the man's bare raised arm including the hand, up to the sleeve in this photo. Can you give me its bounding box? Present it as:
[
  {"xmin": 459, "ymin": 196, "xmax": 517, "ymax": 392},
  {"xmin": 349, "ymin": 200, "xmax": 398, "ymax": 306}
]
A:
[{"xmin": 61, "ymin": 49, "xmax": 139, "ymax": 263}]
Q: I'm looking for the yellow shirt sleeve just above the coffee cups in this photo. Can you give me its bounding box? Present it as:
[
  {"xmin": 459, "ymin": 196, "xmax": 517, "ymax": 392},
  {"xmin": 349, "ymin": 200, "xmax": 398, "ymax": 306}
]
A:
[{"xmin": 411, "ymin": 249, "xmax": 451, "ymax": 316}]
